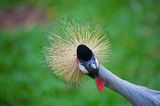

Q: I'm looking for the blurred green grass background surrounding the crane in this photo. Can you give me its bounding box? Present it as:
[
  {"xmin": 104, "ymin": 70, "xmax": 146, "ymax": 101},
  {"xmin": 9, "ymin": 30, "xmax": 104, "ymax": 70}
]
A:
[{"xmin": 0, "ymin": 0, "xmax": 160, "ymax": 106}]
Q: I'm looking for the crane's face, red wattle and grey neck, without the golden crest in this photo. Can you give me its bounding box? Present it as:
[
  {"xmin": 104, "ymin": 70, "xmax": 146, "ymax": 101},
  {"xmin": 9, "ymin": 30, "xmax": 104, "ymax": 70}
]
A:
[{"xmin": 77, "ymin": 45, "xmax": 160, "ymax": 106}]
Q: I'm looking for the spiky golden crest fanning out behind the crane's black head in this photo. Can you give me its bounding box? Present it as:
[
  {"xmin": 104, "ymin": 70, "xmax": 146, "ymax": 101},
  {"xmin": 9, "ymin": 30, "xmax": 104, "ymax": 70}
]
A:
[{"xmin": 45, "ymin": 18, "xmax": 109, "ymax": 83}]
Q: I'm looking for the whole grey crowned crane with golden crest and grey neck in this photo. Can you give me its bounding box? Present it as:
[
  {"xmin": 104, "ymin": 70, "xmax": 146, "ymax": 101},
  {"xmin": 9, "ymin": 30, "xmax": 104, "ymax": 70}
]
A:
[{"xmin": 45, "ymin": 19, "xmax": 160, "ymax": 106}]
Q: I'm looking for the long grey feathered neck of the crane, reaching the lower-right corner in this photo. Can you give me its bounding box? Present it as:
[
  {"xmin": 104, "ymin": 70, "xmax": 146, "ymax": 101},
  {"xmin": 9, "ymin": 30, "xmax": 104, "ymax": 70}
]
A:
[{"xmin": 99, "ymin": 66, "xmax": 160, "ymax": 106}]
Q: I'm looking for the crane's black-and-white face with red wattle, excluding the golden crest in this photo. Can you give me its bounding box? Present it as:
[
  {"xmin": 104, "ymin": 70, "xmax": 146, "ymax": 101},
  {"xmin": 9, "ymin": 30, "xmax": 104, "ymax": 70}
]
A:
[{"xmin": 77, "ymin": 44, "xmax": 104, "ymax": 91}]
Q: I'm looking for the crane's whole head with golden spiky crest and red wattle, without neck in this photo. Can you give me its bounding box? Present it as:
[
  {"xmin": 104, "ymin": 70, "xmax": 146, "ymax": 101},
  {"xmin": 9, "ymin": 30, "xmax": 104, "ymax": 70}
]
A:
[{"xmin": 45, "ymin": 18, "xmax": 109, "ymax": 90}]
